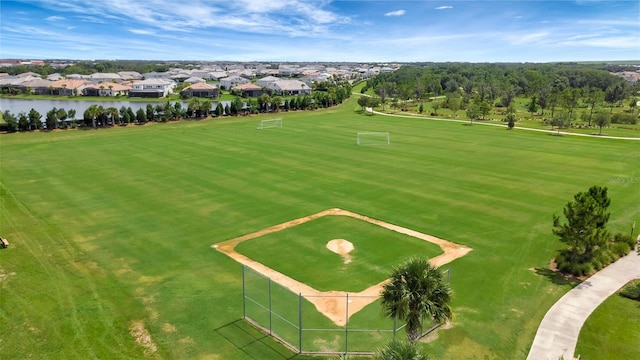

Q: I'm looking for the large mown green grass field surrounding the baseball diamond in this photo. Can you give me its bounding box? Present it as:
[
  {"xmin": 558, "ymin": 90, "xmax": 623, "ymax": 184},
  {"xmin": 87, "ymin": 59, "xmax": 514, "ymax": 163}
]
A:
[{"xmin": 0, "ymin": 93, "xmax": 640, "ymax": 359}]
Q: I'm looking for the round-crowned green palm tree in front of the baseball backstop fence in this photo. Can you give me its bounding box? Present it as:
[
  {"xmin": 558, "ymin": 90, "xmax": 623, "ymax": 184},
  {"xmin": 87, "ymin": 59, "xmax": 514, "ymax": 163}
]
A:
[{"xmin": 381, "ymin": 258, "xmax": 452, "ymax": 343}]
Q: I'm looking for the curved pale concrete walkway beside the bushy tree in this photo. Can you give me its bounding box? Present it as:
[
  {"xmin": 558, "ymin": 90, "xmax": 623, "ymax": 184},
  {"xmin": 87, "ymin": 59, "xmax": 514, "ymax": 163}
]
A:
[{"xmin": 527, "ymin": 250, "xmax": 640, "ymax": 360}]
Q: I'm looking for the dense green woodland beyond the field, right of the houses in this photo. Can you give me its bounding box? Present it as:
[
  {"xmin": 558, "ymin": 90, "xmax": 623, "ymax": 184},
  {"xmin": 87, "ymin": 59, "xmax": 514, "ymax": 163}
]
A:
[{"xmin": 359, "ymin": 63, "xmax": 640, "ymax": 132}]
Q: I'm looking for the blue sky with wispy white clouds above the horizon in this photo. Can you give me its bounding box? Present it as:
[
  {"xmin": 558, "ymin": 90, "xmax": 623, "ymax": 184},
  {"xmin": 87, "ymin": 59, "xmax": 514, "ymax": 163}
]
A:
[{"xmin": 0, "ymin": 0, "xmax": 640, "ymax": 62}]
